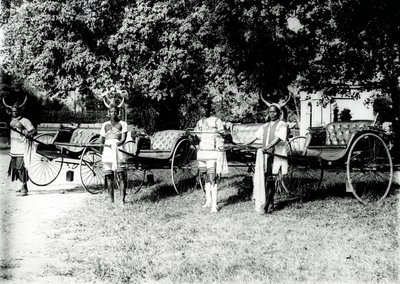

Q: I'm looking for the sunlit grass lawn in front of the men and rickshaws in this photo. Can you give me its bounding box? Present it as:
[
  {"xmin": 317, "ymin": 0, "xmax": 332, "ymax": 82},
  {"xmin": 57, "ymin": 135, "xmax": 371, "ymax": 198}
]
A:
[{"xmin": 46, "ymin": 170, "xmax": 399, "ymax": 283}]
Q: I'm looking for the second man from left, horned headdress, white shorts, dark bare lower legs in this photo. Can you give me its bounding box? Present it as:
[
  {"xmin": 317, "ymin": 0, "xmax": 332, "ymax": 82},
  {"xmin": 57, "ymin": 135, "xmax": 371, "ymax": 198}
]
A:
[{"xmin": 100, "ymin": 97, "xmax": 128, "ymax": 204}]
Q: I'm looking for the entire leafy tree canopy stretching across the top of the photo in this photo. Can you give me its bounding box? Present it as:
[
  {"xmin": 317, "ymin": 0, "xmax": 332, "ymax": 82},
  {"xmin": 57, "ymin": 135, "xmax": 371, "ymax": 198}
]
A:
[{"xmin": 2, "ymin": 0, "xmax": 400, "ymax": 158}]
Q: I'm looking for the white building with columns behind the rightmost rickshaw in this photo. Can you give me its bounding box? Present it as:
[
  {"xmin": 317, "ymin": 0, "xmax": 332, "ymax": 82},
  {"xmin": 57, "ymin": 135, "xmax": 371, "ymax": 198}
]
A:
[{"xmin": 300, "ymin": 91, "xmax": 375, "ymax": 135}]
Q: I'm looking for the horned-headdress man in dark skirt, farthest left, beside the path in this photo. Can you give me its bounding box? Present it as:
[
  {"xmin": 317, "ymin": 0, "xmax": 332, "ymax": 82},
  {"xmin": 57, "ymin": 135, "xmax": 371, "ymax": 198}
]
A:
[{"xmin": 3, "ymin": 96, "xmax": 36, "ymax": 196}]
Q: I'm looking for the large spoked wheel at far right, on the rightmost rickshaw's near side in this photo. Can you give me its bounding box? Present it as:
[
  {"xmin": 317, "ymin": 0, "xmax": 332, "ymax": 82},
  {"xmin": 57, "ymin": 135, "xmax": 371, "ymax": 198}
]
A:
[{"xmin": 347, "ymin": 133, "xmax": 393, "ymax": 204}]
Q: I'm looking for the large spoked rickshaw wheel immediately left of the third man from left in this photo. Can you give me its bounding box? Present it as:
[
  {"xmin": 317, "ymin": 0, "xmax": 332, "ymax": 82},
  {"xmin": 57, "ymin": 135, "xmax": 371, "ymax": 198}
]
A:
[{"xmin": 171, "ymin": 139, "xmax": 198, "ymax": 194}]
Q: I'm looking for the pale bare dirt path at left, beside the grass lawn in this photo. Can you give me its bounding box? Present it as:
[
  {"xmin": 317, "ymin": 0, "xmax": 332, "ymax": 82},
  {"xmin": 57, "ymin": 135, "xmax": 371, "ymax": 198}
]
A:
[{"xmin": 0, "ymin": 150, "xmax": 91, "ymax": 283}]
